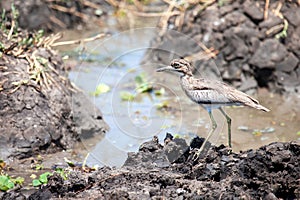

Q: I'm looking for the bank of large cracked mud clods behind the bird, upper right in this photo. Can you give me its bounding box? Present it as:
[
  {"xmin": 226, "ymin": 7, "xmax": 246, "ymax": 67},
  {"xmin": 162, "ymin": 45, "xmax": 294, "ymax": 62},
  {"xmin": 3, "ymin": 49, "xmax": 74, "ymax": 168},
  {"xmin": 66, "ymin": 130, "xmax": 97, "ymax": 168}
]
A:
[{"xmin": 145, "ymin": 0, "xmax": 300, "ymax": 94}]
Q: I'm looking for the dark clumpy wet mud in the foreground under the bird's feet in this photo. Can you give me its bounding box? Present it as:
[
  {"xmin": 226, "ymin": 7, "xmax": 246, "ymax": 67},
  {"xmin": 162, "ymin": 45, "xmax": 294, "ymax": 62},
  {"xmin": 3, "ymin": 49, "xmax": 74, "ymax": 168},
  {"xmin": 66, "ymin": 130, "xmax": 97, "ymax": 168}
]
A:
[{"xmin": 22, "ymin": 139, "xmax": 300, "ymax": 199}]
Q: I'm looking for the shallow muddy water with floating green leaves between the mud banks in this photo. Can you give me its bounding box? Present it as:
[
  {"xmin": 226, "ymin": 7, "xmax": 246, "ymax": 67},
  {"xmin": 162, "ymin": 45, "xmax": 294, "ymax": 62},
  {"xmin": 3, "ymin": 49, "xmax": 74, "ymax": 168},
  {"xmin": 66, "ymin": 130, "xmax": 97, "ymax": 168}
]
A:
[{"xmin": 59, "ymin": 28, "xmax": 300, "ymax": 166}]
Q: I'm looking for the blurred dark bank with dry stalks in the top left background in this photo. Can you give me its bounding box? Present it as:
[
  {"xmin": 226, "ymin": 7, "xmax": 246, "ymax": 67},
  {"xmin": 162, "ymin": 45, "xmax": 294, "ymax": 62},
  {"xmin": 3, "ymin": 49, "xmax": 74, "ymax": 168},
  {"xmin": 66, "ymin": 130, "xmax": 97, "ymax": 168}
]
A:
[{"xmin": 0, "ymin": 0, "xmax": 109, "ymax": 32}]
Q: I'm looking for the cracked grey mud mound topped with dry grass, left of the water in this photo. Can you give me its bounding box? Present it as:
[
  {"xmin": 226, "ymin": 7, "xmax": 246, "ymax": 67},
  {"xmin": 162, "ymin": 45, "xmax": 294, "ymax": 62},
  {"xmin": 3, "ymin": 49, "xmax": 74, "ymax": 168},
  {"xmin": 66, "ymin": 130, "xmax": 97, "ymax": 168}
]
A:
[{"xmin": 0, "ymin": 22, "xmax": 107, "ymax": 160}]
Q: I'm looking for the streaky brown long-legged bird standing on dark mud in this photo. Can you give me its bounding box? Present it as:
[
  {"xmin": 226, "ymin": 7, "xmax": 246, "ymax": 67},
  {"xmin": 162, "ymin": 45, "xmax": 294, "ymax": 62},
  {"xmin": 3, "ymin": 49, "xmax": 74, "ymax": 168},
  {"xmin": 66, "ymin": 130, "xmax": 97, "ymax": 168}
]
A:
[{"xmin": 156, "ymin": 59, "xmax": 270, "ymax": 156}]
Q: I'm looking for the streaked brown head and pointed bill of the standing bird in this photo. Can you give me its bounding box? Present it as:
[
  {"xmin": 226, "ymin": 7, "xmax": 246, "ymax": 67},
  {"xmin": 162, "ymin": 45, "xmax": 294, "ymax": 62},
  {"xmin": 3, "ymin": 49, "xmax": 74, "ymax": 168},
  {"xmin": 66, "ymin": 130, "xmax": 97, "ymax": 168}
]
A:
[{"xmin": 156, "ymin": 59, "xmax": 193, "ymax": 76}]
